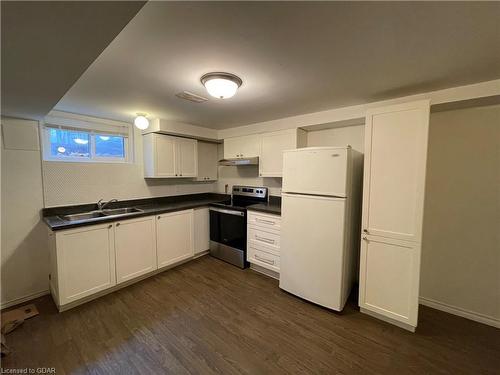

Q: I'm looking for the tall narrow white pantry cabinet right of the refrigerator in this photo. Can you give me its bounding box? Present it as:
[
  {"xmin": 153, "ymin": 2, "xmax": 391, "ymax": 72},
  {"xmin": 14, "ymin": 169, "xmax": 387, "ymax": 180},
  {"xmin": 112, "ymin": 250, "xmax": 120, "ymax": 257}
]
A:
[{"xmin": 359, "ymin": 100, "xmax": 430, "ymax": 331}]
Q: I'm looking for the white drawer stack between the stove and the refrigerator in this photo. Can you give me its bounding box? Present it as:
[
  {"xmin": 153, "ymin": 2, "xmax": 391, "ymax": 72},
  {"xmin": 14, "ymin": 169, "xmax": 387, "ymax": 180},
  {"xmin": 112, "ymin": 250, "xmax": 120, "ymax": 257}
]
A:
[{"xmin": 247, "ymin": 211, "xmax": 281, "ymax": 272}]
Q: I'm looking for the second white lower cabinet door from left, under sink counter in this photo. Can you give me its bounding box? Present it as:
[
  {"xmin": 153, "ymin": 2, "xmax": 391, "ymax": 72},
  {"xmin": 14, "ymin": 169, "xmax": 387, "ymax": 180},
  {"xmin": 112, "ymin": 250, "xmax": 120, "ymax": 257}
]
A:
[{"xmin": 115, "ymin": 216, "xmax": 156, "ymax": 284}]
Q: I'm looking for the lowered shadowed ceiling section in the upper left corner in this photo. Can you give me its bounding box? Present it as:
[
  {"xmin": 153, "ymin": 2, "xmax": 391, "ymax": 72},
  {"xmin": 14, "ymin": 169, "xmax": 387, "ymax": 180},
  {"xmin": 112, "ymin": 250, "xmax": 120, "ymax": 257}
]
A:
[{"xmin": 1, "ymin": 1, "xmax": 145, "ymax": 119}]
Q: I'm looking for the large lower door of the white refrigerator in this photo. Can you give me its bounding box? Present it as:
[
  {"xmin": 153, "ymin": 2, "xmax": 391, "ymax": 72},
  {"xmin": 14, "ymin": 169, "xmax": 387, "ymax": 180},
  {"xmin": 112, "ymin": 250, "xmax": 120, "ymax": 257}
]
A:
[{"xmin": 280, "ymin": 194, "xmax": 346, "ymax": 311}]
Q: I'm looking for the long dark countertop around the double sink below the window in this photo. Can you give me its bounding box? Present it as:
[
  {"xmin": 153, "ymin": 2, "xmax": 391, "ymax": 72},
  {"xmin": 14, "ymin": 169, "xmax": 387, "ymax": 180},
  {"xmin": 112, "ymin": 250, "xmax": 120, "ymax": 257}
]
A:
[{"xmin": 41, "ymin": 193, "xmax": 231, "ymax": 231}]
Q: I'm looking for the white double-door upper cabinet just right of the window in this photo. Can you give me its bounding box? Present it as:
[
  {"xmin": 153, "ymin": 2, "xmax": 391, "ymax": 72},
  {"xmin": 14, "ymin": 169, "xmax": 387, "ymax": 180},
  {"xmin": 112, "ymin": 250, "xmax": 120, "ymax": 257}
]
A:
[{"xmin": 142, "ymin": 133, "xmax": 198, "ymax": 178}]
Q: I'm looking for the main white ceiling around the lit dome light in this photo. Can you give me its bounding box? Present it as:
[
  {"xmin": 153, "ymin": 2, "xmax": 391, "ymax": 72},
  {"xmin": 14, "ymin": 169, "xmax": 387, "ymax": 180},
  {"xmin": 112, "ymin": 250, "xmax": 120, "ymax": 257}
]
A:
[{"xmin": 56, "ymin": 2, "xmax": 500, "ymax": 129}]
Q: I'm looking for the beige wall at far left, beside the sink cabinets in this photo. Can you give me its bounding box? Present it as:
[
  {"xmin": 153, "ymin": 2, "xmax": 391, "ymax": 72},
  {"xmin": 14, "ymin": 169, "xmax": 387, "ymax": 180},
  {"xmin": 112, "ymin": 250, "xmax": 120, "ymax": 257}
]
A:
[{"xmin": 1, "ymin": 119, "xmax": 48, "ymax": 306}]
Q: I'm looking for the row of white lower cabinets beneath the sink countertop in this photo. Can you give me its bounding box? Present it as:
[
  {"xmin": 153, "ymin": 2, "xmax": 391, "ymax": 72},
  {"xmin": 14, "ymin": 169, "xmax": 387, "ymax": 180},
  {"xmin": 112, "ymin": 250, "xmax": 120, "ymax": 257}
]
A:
[{"xmin": 49, "ymin": 209, "xmax": 197, "ymax": 311}]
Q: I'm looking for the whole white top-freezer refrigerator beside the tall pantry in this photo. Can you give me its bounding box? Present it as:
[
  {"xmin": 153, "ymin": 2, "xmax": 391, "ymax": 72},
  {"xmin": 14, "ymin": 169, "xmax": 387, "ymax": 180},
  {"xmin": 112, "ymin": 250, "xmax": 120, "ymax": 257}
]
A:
[{"xmin": 280, "ymin": 146, "xmax": 358, "ymax": 311}]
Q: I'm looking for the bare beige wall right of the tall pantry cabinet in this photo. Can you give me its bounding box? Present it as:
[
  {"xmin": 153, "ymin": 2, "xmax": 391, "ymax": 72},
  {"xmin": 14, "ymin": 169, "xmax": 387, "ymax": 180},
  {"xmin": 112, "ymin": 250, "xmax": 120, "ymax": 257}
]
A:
[{"xmin": 420, "ymin": 105, "xmax": 500, "ymax": 322}]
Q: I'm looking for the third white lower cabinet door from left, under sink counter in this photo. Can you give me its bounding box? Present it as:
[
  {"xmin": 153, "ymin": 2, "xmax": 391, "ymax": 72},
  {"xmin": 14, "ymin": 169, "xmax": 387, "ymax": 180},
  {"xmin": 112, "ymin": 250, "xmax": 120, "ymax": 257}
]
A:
[{"xmin": 156, "ymin": 210, "xmax": 194, "ymax": 268}]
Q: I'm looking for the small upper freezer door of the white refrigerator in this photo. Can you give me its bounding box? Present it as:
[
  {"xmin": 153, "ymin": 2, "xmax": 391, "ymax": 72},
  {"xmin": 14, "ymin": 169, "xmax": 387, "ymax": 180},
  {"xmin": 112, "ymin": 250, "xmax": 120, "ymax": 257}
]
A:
[{"xmin": 282, "ymin": 147, "xmax": 351, "ymax": 197}]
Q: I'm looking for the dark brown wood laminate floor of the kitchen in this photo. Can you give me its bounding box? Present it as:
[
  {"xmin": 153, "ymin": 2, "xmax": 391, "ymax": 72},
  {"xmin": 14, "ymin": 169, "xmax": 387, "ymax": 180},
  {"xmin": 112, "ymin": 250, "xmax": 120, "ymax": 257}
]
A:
[{"xmin": 2, "ymin": 256, "xmax": 500, "ymax": 375}]
